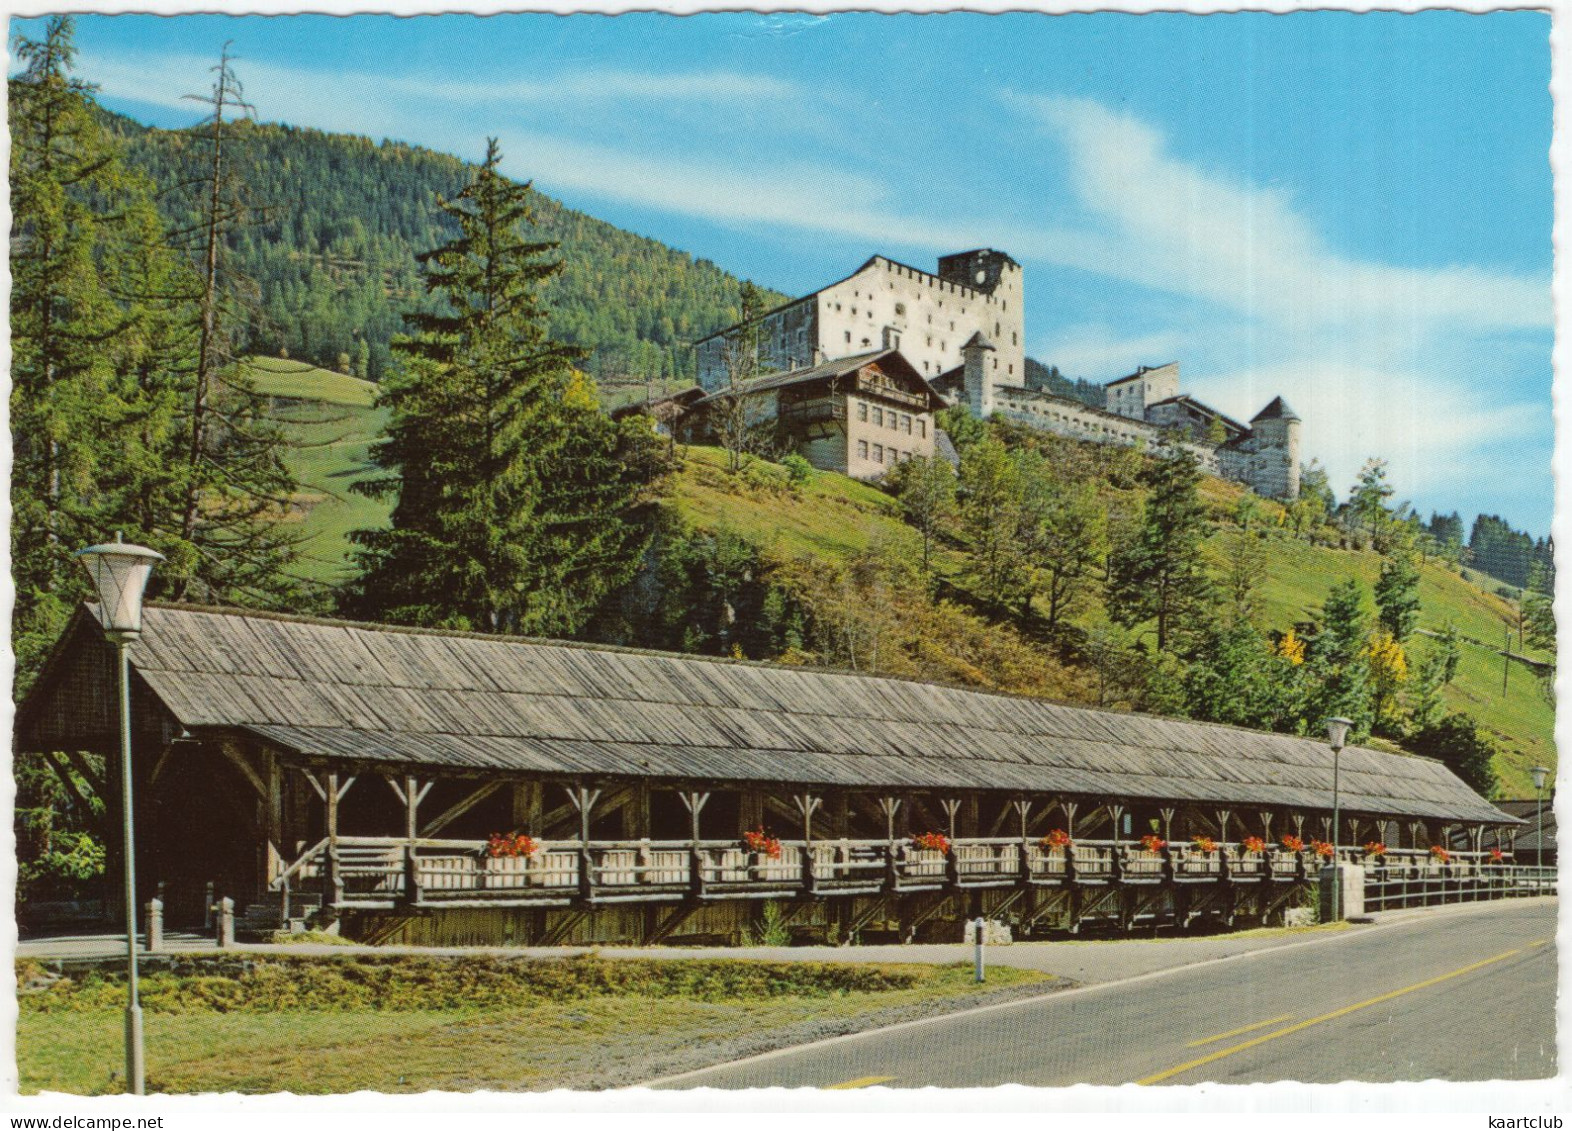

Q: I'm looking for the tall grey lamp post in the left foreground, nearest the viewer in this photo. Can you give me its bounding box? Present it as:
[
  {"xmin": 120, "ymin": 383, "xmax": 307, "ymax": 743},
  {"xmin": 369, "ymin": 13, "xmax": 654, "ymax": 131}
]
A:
[{"xmin": 77, "ymin": 533, "xmax": 163, "ymax": 1096}]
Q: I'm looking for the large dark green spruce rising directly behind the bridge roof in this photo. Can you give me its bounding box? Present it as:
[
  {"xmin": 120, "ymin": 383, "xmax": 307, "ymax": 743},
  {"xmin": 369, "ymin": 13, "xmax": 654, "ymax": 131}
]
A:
[{"xmin": 346, "ymin": 140, "xmax": 656, "ymax": 635}]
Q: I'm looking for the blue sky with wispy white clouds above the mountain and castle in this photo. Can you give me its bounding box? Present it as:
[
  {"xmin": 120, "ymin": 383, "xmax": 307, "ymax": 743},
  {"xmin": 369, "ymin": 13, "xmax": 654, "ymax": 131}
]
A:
[{"xmin": 13, "ymin": 11, "xmax": 1553, "ymax": 535}]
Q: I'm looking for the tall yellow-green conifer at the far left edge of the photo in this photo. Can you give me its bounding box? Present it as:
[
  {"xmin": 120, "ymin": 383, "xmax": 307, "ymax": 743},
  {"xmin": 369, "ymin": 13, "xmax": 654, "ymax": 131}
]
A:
[{"xmin": 9, "ymin": 16, "xmax": 124, "ymax": 672}]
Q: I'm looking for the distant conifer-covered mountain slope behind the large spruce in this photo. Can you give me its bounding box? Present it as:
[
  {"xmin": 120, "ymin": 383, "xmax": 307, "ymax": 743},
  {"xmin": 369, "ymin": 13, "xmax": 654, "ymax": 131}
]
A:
[{"xmin": 105, "ymin": 112, "xmax": 781, "ymax": 387}]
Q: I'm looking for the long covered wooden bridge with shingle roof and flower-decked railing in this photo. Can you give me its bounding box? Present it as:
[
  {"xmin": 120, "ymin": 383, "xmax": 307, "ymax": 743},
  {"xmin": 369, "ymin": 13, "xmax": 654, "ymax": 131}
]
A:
[{"xmin": 16, "ymin": 606, "xmax": 1512, "ymax": 944}]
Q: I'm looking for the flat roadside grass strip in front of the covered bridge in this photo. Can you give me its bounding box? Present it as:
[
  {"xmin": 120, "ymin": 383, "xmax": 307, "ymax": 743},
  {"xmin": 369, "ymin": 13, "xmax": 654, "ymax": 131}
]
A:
[{"xmin": 17, "ymin": 955, "xmax": 1055, "ymax": 1095}]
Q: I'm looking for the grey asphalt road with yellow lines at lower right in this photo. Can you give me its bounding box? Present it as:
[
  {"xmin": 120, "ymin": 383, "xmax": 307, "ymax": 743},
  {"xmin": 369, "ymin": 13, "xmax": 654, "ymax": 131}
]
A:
[{"xmin": 656, "ymin": 900, "xmax": 1558, "ymax": 1089}]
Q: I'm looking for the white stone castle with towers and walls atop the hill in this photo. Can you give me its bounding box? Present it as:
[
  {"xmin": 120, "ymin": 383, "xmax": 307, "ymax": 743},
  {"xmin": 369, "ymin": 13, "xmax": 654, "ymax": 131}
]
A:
[{"xmin": 695, "ymin": 249, "xmax": 1300, "ymax": 499}]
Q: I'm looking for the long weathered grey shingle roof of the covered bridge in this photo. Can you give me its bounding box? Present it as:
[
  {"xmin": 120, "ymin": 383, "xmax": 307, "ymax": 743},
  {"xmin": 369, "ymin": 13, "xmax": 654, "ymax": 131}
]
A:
[{"xmin": 17, "ymin": 606, "xmax": 1511, "ymax": 824}]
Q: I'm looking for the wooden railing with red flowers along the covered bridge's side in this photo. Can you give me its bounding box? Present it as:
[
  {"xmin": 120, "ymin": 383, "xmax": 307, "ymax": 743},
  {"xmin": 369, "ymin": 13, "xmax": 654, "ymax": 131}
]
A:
[{"xmin": 274, "ymin": 837, "xmax": 1501, "ymax": 908}]
